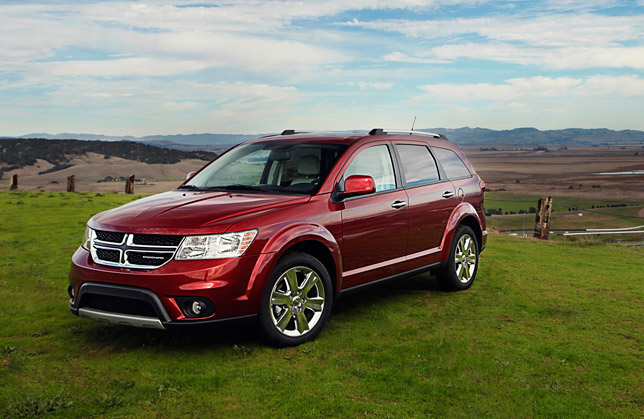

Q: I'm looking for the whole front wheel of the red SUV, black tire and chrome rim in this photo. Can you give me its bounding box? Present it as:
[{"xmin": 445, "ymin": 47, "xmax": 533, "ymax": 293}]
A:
[{"xmin": 259, "ymin": 252, "xmax": 333, "ymax": 347}]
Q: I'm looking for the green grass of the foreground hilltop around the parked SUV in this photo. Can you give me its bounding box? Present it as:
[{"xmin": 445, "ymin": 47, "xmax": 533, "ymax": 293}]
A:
[{"xmin": 0, "ymin": 192, "xmax": 644, "ymax": 418}]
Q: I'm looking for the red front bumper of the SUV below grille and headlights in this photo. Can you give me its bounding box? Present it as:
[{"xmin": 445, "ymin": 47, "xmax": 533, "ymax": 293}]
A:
[{"xmin": 69, "ymin": 248, "xmax": 266, "ymax": 329}]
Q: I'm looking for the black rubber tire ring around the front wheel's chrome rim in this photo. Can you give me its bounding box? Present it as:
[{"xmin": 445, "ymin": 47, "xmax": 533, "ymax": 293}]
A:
[{"xmin": 258, "ymin": 253, "xmax": 333, "ymax": 347}]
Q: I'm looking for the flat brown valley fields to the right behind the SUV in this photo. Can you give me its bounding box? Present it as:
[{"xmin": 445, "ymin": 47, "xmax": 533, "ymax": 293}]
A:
[{"xmin": 463, "ymin": 145, "xmax": 644, "ymax": 201}]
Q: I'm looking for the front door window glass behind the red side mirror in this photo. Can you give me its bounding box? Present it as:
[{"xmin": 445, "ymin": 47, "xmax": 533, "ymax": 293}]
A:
[{"xmin": 344, "ymin": 145, "xmax": 396, "ymax": 192}]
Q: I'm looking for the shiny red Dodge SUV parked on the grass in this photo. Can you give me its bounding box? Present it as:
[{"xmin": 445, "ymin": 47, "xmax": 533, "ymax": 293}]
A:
[{"xmin": 69, "ymin": 129, "xmax": 487, "ymax": 346}]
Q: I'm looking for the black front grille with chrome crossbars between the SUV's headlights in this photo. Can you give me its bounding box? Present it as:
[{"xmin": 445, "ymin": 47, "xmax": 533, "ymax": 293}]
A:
[{"xmin": 91, "ymin": 230, "xmax": 183, "ymax": 269}]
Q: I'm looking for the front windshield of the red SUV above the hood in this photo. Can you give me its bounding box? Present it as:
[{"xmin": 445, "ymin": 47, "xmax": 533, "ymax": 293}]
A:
[{"xmin": 179, "ymin": 141, "xmax": 346, "ymax": 195}]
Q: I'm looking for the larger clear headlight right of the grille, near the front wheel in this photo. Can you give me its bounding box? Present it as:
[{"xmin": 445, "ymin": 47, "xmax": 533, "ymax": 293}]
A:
[{"xmin": 175, "ymin": 230, "xmax": 257, "ymax": 260}]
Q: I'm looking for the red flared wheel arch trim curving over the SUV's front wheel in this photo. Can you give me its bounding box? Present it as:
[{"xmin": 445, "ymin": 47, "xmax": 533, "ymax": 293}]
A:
[{"xmin": 243, "ymin": 223, "xmax": 342, "ymax": 311}]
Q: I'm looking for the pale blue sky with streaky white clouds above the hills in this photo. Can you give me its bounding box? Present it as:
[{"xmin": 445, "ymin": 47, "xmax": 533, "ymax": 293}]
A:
[{"xmin": 0, "ymin": 0, "xmax": 644, "ymax": 135}]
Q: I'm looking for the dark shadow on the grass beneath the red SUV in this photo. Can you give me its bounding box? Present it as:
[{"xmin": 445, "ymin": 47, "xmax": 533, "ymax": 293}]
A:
[{"xmin": 69, "ymin": 273, "xmax": 445, "ymax": 353}]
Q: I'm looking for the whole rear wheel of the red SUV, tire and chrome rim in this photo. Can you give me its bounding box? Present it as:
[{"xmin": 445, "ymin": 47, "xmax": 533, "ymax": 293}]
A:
[{"xmin": 436, "ymin": 225, "xmax": 479, "ymax": 291}]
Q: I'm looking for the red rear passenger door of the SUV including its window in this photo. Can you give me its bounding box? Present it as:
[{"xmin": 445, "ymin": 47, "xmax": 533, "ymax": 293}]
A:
[{"xmin": 394, "ymin": 141, "xmax": 459, "ymax": 270}]
